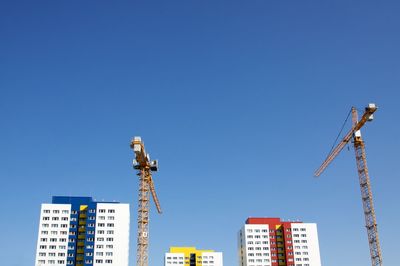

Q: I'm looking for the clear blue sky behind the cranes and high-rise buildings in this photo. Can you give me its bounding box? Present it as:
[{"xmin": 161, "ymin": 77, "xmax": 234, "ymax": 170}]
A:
[{"xmin": 0, "ymin": 0, "xmax": 400, "ymax": 266}]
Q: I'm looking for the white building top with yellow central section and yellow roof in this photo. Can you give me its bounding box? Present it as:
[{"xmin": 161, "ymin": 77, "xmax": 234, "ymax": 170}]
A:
[{"xmin": 164, "ymin": 247, "xmax": 223, "ymax": 266}]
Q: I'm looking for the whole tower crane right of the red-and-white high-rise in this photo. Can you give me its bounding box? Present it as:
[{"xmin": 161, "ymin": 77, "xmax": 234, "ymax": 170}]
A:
[{"xmin": 314, "ymin": 104, "xmax": 383, "ymax": 266}]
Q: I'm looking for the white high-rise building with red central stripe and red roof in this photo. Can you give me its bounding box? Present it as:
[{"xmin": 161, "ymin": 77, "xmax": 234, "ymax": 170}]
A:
[{"xmin": 238, "ymin": 218, "xmax": 321, "ymax": 266}]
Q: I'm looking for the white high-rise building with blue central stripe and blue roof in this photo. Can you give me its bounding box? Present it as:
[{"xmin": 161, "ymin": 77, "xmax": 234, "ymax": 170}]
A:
[{"xmin": 35, "ymin": 196, "xmax": 130, "ymax": 266}]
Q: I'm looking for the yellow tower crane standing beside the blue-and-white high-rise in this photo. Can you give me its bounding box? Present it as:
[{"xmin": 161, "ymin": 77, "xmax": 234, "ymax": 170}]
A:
[{"xmin": 130, "ymin": 137, "xmax": 161, "ymax": 266}]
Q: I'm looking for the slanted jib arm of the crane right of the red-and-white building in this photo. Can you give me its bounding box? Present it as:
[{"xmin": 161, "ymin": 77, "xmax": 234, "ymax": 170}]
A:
[{"xmin": 314, "ymin": 103, "xmax": 378, "ymax": 177}]
